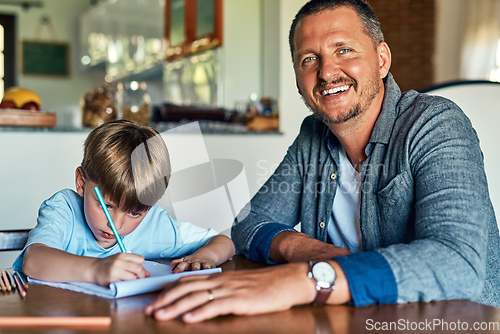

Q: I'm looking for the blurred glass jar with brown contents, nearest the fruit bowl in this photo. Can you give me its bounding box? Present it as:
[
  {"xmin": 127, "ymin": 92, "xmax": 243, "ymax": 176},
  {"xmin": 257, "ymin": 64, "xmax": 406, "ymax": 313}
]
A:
[{"xmin": 81, "ymin": 85, "xmax": 118, "ymax": 128}]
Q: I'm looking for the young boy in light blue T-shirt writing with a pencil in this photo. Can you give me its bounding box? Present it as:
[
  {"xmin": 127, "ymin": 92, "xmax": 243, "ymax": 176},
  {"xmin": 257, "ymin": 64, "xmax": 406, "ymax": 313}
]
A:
[{"xmin": 13, "ymin": 120, "xmax": 234, "ymax": 286}]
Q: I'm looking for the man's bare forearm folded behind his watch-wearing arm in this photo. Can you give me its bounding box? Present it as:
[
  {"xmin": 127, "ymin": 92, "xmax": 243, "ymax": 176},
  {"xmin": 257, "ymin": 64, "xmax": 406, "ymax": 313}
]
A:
[{"xmin": 269, "ymin": 231, "xmax": 351, "ymax": 262}]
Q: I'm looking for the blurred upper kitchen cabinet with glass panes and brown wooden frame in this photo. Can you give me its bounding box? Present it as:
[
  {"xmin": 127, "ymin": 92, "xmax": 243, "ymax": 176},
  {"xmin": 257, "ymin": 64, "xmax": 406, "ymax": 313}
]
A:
[{"xmin": 79, "ymin": 0, "xmax": 222, "ymax": 82}]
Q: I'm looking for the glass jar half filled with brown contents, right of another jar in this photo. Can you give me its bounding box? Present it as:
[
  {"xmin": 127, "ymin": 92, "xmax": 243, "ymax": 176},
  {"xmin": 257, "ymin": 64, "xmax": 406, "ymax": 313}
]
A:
[{"xmin": 118, "ymin": 81, "xmax": 152, "ymax": 125}]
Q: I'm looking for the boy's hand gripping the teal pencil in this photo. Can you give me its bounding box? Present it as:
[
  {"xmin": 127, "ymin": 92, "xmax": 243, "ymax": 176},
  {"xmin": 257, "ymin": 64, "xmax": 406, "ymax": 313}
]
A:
[{"xmin": 92, "ymin": 253, "xmax": 150, "ymax": 286}]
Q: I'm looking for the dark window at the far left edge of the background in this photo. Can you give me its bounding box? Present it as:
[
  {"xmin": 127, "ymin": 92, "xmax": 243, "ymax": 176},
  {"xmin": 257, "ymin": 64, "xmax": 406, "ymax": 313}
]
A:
[{"xmin": 0, "ymin": 15, "xmax": 16, "ymax": 96}]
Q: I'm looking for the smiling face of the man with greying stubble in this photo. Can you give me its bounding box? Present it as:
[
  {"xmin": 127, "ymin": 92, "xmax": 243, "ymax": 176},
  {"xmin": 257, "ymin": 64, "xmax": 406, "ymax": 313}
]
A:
[{"xmin": 293, "ymin": 7, "xmax": 390, "ymax": 124}]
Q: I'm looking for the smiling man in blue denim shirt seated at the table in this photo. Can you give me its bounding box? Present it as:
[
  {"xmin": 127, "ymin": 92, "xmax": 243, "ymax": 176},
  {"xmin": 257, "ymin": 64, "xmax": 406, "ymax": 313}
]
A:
[{"xmin": 146, "ymin": 0, "xmax": 500, "ymax": 322}]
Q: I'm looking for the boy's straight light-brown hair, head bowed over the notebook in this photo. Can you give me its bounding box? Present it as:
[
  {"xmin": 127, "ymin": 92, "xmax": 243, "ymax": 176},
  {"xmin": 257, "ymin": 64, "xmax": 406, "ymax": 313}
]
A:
[{"xmin": 81, "ymin": 120, "xmax": 171, "ymax": 211}]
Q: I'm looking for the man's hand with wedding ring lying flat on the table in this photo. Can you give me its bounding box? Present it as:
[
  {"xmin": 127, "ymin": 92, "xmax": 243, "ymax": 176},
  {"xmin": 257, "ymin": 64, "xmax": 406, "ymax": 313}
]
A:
[{"xmin": 145, "ymin": 263, "xmax": 316, "ymax": 323}]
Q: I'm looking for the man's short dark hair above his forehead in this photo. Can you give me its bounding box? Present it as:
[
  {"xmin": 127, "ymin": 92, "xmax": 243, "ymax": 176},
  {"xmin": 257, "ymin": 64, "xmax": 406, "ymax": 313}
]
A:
[{"xmin": 288, "ymin": 0, "xmax": 384, "ymax": 59}]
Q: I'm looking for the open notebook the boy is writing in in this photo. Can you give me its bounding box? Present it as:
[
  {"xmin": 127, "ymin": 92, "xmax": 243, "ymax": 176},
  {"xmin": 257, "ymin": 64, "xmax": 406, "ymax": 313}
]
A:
[{"xmin": 28, "ymin": 261, "xmax": 222, "ymax": 298}]
